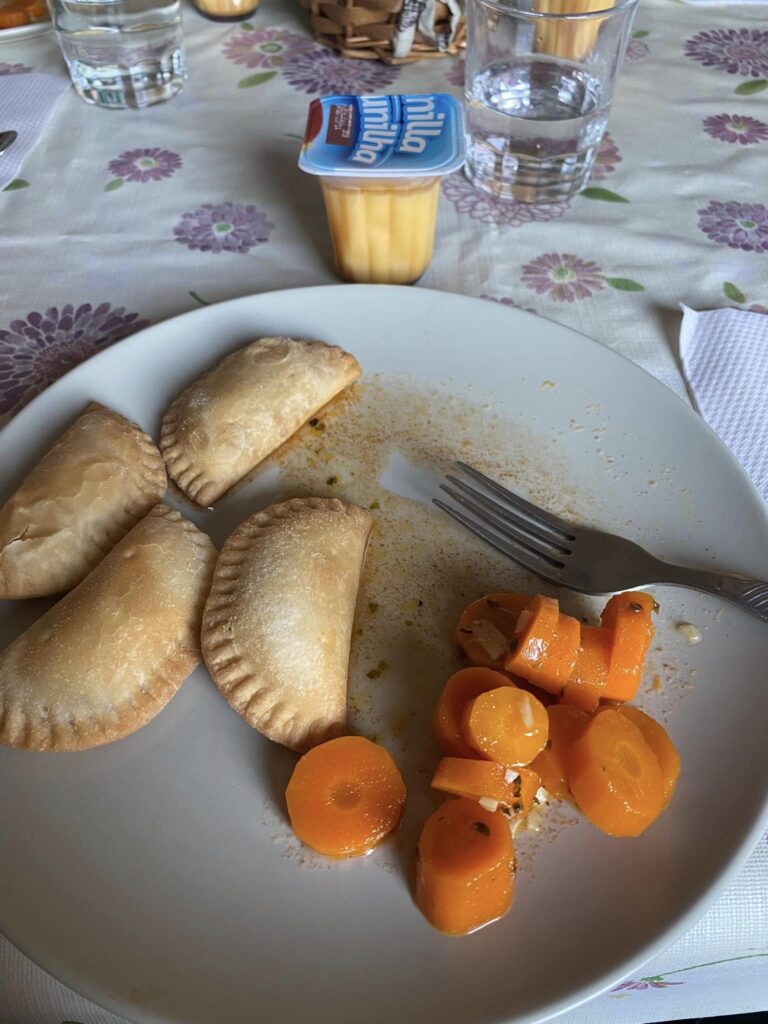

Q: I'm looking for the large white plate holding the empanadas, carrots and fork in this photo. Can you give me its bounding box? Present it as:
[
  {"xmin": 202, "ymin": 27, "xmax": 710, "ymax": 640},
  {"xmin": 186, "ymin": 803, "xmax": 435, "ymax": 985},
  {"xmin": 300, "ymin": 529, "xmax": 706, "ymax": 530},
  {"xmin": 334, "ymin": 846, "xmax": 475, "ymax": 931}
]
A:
[{"xmin": 0, "ymin": 287, "xmax": 768, "ymax": 1024}]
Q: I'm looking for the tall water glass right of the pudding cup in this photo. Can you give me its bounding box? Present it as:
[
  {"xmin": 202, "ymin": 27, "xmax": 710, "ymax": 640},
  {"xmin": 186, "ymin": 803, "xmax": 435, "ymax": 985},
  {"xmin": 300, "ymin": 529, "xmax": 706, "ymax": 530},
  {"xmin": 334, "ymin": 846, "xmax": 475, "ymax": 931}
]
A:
[{"xmin": 464, "ymin": 0, "xmax": 637, "ymax": 203}]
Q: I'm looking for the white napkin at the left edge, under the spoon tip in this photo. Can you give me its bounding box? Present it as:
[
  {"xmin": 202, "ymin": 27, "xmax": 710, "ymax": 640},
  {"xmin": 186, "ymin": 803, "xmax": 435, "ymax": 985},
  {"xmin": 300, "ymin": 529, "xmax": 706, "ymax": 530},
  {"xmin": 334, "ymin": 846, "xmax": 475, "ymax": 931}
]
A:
[{"xmin": 0, "ymin": 72, "xmax": 70, "ymax": 189}]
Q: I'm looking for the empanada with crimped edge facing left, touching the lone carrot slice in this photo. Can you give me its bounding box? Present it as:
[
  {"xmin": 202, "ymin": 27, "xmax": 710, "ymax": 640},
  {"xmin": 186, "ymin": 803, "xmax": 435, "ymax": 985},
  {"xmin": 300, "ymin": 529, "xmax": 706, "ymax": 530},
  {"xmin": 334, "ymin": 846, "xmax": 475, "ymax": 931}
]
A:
[{"xmin": 202, "ymin": 498, "xmax": 373, "ymax": 751}]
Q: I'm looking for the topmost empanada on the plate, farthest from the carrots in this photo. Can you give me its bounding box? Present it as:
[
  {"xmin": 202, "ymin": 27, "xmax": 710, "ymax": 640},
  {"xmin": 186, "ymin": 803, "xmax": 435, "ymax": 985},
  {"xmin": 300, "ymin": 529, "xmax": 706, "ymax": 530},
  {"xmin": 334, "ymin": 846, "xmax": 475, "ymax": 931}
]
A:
[{"xmin": 160, "ymin": 338, "xmax": 362, "ymax": 507}]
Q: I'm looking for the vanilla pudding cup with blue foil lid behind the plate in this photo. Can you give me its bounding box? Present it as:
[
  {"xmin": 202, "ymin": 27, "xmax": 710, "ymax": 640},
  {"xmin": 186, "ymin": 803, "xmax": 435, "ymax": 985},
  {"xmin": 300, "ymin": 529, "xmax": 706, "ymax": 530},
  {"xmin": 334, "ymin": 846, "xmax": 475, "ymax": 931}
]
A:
[{"xmin": 299, "ymin": 93, "xmax": 464, "ymax": 285}]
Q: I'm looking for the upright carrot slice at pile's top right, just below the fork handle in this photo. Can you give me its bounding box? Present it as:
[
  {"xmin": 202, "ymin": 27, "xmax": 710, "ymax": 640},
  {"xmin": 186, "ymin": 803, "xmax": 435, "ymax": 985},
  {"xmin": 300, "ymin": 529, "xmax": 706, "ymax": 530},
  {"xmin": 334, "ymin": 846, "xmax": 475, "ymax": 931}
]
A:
[{"xmin": 601, "ymin": 591, "xmax": 658, "ymax": 700}]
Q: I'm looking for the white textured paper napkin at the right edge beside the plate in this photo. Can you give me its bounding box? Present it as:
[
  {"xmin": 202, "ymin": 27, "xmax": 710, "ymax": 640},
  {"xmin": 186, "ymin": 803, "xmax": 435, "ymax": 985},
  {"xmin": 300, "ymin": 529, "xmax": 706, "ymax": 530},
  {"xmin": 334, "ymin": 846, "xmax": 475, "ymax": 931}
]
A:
[{"xmin": 680, "ymin": 306, "xmax": 768, "ymax": 501}]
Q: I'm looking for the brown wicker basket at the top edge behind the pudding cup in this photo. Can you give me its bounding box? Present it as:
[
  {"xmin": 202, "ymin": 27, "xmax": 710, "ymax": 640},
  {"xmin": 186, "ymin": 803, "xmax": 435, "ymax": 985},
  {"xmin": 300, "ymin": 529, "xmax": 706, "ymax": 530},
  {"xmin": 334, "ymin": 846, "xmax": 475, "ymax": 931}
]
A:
[{"xmin": 301, "ymin": 0, "xmax": 467, "ymax": 65}]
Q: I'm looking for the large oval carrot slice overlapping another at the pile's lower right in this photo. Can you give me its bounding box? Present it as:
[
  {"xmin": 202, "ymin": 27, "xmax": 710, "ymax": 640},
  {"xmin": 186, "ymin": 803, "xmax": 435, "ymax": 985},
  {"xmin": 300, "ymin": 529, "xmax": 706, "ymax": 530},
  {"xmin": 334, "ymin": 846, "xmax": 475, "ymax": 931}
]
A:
[{"xmin": 565, "ymin": 708, "xmax": 665, "ymax": 836}]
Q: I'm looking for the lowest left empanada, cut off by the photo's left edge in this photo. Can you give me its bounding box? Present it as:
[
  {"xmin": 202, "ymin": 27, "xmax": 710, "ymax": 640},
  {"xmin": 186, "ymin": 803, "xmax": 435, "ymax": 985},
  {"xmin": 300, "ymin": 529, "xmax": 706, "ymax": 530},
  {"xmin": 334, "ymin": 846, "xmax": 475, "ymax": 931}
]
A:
[{"xmin": 0, "ymin": 505, "xmax": 216, "ymax": 751}]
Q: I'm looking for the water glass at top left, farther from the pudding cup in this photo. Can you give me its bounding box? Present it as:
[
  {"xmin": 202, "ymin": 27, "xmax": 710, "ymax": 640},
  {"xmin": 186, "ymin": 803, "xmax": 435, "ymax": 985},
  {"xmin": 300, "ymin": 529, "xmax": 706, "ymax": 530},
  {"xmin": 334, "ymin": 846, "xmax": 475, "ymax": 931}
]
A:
[{"xmin": 48, "ymin": 0, "xmax": 186, "ymax": 109}]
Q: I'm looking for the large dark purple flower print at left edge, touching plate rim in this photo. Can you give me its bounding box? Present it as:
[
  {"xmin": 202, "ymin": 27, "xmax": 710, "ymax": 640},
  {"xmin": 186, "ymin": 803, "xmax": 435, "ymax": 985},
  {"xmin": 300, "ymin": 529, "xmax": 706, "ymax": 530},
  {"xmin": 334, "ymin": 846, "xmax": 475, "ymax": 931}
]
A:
[{"xmin": 0, "ymin": 302, "xmax": 150, "ymax": 414}]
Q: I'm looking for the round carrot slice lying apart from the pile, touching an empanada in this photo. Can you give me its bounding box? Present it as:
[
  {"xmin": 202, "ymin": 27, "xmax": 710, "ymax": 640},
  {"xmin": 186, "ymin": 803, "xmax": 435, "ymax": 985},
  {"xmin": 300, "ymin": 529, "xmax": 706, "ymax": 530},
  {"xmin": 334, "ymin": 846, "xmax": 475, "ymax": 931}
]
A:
[{"xmin": 286, "ymin": 736, "xmax": 406, "ymax": 858}]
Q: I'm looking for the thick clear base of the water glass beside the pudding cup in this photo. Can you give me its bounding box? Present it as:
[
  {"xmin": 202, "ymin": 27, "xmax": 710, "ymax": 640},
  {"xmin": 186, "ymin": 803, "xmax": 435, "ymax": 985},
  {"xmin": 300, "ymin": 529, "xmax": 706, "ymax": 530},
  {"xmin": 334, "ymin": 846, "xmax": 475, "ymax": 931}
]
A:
[{"xmin": 464, "ymin": 146, "xmax": 597, "ymax": 204}]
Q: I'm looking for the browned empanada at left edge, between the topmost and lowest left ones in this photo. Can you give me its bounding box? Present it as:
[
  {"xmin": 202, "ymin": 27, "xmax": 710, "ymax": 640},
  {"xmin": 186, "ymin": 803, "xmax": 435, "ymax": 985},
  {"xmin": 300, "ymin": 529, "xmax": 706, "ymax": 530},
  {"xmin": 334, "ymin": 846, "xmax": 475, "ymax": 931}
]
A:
[{"xmin": 0, "ymin": 402, "xmax": 167, "ymax": 598}]
